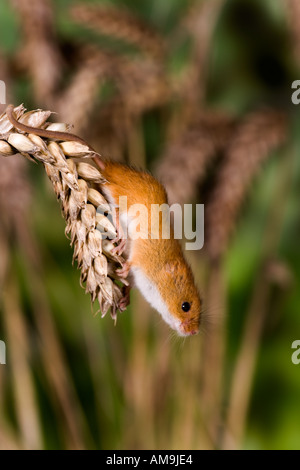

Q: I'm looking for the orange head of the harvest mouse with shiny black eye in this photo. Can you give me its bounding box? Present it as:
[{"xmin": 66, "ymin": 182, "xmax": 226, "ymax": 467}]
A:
[{"xmin": 159, "ymin": 259, "xmax": 201, "ymax": 336}]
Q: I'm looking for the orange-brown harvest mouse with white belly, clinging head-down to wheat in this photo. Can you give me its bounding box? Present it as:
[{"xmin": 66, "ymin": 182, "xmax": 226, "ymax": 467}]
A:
[{"xmin": 101, "ymin": 161, "xmax": 201, "ymax": 336}]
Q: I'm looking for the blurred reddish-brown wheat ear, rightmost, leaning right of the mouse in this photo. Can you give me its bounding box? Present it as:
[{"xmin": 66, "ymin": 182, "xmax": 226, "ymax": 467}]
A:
[{"xmin": 206, "ymin": 109, "xmax": 287, "ymax": 259}]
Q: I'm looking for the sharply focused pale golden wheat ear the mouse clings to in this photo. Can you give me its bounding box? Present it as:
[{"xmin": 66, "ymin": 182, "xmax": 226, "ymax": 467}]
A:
[{"xmin": 0, "ymin": 105, "xmax": 126, "ymax": 320}]
